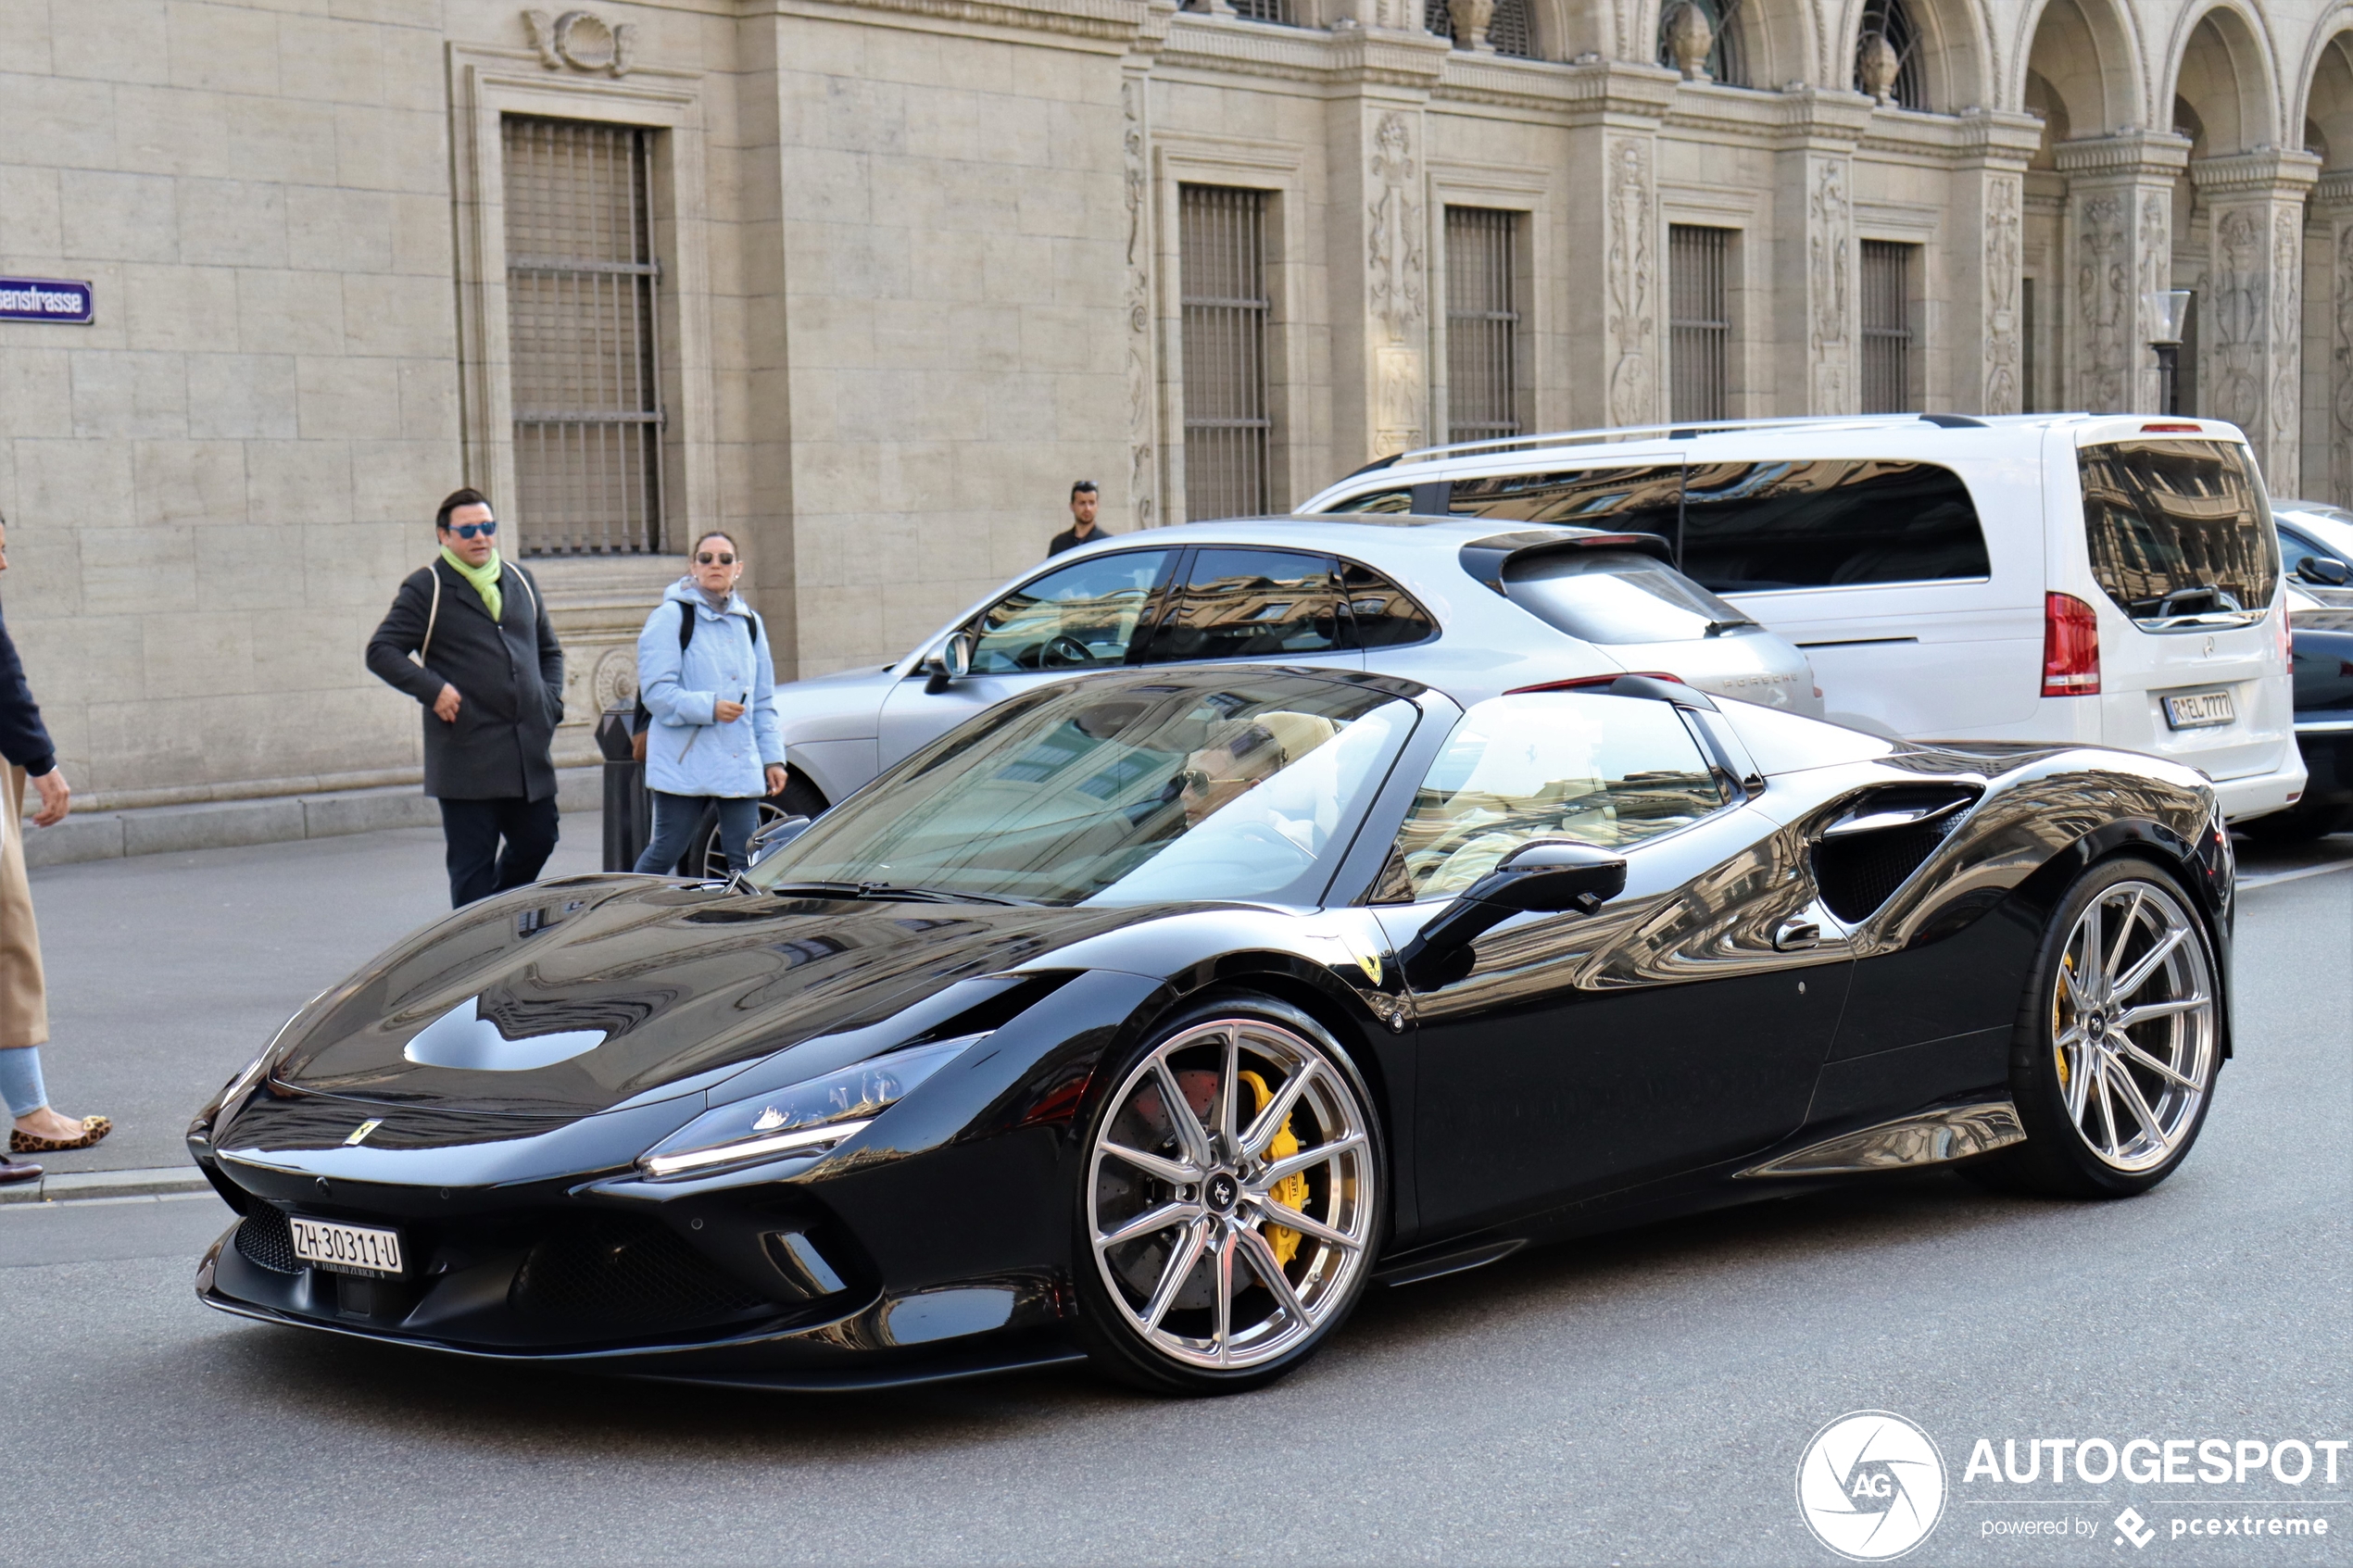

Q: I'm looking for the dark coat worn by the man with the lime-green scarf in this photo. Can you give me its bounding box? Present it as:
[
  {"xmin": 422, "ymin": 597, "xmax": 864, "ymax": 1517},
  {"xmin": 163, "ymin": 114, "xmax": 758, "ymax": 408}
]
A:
[{"xmin": 367, "ymin": 558, "xmax": 565, "ymax": 799}]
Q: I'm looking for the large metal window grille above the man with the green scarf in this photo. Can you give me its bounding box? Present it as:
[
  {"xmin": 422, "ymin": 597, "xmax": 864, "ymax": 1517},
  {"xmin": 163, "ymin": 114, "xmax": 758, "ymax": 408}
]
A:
[{"xmin": 501, "ymin": 115, "xmax": 663, "ymax": 555}]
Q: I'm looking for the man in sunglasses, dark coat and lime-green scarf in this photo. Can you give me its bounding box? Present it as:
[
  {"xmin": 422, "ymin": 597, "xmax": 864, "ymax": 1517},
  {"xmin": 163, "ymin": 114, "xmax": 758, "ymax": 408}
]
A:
[{"xmin": 367, "ymin": 489, "xmax": 565, "ymax": 908}]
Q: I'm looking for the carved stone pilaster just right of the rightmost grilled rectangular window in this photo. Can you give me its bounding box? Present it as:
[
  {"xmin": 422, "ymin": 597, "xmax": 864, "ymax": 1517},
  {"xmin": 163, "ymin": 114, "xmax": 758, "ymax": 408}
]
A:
[{"xmin": 1951, "ymin": 108, "xmax": 2040, "ymax": 414}]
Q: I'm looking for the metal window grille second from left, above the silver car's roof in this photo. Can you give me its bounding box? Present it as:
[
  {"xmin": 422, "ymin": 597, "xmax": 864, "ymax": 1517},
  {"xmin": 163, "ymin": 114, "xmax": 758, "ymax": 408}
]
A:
[{"xmin": 1176, "ymin": 186, "xmax": 1273, "ymax": 520}]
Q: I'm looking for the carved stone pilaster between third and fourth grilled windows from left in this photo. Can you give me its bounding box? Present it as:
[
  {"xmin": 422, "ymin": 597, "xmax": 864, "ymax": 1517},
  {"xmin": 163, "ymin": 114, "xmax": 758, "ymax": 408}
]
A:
[{"xmin": 1565, "ymin": 61, "xmax": 1678, "ymax": 425}]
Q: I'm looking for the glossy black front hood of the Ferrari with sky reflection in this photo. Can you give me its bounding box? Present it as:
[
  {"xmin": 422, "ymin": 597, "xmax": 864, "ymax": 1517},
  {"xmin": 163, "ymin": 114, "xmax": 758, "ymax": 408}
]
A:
[{"xmin": 271, "ymin": 877, "xmax": 1160, "ymax": 1117}]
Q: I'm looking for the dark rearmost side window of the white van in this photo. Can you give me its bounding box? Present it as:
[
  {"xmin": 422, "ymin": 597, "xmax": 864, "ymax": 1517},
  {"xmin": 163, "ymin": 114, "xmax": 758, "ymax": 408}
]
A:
[{"xmin": 1682, "ymin": 458, "xmax": 1993, "ymax": 593}]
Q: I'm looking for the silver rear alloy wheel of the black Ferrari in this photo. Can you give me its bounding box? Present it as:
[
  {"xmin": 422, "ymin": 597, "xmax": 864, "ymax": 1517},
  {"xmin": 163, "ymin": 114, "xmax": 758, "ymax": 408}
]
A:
[{"xmin": 2052, "ymin": 882, "xmax": 2217, "ymax": 1171}]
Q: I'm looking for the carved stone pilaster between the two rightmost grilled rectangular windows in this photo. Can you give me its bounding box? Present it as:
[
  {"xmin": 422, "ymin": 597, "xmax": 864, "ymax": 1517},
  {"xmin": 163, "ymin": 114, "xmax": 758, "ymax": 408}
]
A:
[{"xmin": 1774, "ymin": 87, "xmax": 1870, "ymax": 414}]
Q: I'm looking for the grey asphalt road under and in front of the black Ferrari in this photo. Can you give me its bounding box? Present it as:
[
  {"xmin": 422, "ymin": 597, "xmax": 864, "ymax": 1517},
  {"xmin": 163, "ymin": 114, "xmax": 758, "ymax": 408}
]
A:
[{"xmin": 0, "ymin": 856, "xmax": 2353, "ymax": 1563}]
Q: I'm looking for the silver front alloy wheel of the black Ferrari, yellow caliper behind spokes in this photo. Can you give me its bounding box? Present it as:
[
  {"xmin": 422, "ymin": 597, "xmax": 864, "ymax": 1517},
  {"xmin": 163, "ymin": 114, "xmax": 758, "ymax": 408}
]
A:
[{"xmin": 1087, "ymin": 1018, "xmax": 1378, "ymax": 1371}]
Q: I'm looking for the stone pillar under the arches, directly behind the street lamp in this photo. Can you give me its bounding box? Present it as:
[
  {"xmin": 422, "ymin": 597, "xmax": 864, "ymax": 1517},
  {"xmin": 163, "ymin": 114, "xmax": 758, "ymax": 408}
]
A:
[{"xmin": 2059, "ymin": 132, "xmax": 2191, "ymax": 414}]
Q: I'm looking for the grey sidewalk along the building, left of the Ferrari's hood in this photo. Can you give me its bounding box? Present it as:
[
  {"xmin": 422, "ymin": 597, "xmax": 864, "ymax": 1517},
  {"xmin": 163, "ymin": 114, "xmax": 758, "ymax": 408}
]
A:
[{"xmin": 33, "ymin": 811, "xmax": 602, "ymax": 1173}]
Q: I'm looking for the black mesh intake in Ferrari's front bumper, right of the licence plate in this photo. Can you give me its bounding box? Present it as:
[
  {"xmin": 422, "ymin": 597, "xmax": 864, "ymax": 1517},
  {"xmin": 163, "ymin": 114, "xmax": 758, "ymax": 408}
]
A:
[{"xmin": 506, "ymin": 1218, "xmax": 767, "ymax": 1333}]
